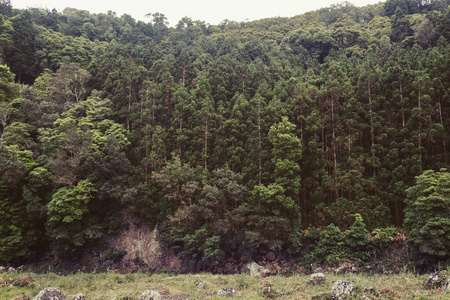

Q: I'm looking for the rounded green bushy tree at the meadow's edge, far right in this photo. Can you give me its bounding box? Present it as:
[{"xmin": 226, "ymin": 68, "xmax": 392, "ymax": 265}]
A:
[{"xmin": 403, "ymin": 169, "xmax": 450, "ymax": 268}]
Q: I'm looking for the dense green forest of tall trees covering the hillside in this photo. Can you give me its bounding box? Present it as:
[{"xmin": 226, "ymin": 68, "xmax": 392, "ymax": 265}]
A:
[{"xmin": 0, "ymin": 0, "xmax": 450, "ymax": 270}]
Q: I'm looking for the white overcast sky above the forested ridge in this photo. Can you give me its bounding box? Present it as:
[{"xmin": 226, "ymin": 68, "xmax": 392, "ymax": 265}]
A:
[{"xmin": 11, "ymin": 0, "xmax": 384, "ymax": 26}]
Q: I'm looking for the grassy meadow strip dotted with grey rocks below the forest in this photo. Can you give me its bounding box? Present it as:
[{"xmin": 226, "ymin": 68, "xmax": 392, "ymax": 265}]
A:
[{"xmin": 0, "ymin": 273, "xmax": 450, "ymax": 300}]
